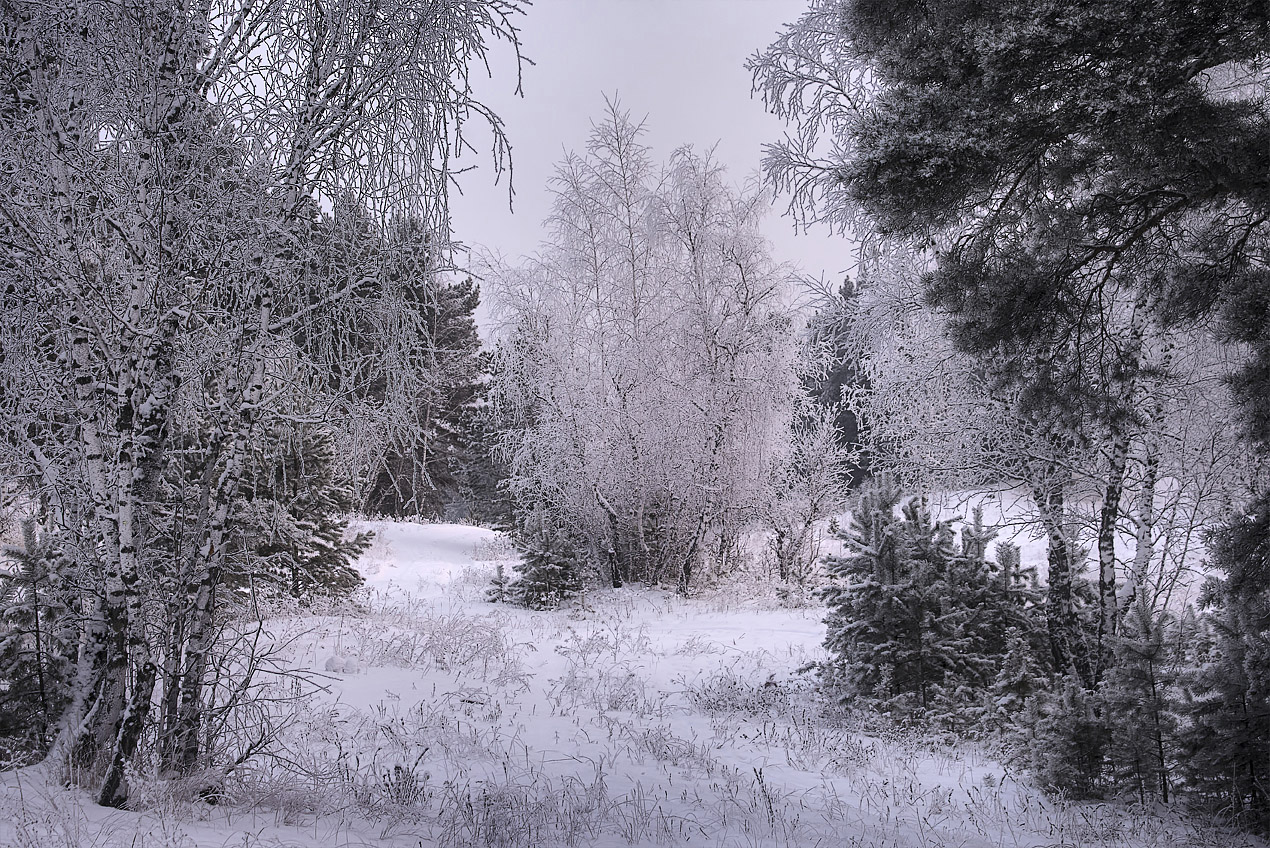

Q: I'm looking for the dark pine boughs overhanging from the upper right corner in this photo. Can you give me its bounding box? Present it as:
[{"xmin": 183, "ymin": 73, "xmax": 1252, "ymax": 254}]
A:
[{"xmin": 761, "ymin": 0, "xmax": 1270, "ymax": 432}]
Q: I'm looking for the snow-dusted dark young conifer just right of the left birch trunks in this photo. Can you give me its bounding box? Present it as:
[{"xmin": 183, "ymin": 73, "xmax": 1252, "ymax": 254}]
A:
[{"xmin": 231, "ymin": 427, "xmax": 372, "ymax": 600}]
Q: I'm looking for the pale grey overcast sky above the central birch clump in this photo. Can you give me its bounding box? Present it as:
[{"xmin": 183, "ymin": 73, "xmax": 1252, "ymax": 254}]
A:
[{"xmin": 451, "ymin": 0, "xmax": 851, "ymax": 303}]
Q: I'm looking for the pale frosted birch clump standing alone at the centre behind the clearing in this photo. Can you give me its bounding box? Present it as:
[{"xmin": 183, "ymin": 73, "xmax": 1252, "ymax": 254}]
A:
[{"xmin": 493, "ymin": 105, "xmax": 796, "ymax": 584}]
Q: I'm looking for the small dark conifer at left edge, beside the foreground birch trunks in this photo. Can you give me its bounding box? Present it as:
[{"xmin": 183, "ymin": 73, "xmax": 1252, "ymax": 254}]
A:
[{"xmin": 0, "ymin": 520, "xmax": 75, "ymax": 768}]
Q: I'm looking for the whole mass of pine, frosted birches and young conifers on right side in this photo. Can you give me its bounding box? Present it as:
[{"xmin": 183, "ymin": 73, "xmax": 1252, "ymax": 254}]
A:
[{"xmin": 751, "ymin": 0, "xmax": 1270, "ymax": 830}]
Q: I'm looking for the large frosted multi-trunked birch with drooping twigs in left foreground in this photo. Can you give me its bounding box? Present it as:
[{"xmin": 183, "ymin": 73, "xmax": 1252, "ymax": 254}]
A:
[{"xmin": 0, "ymin": 0, "xmax": 518, "ymax": 805}]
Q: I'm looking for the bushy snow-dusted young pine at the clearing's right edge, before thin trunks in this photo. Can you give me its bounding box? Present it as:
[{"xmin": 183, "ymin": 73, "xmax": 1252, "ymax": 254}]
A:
[{"xmin": 823, "ymin": 479, "xmax": 1036, "ymax": 729}]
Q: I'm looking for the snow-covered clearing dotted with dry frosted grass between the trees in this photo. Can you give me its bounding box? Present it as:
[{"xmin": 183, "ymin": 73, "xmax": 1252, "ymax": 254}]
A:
[{"xmin": 0, "ymin": 523, "xmax": 1265, "ymax": 848}]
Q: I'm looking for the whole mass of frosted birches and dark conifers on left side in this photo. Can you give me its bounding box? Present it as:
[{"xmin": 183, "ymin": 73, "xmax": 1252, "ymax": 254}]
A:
[{"xmin": 0, "ymin": 0, "xmax": 519, "ymax": 806}]
